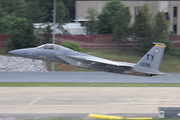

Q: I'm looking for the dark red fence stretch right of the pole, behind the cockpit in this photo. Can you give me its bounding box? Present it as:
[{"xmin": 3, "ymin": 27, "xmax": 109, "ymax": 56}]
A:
[{"xmin": 56, "ymin": 35, "xmax": 138, "ymax": 48}]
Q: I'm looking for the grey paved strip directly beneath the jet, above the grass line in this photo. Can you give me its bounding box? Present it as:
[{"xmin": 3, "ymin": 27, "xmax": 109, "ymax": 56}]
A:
[{"xmin": 0, "ymin": 72, "xmax": 180, "ymax": 83}]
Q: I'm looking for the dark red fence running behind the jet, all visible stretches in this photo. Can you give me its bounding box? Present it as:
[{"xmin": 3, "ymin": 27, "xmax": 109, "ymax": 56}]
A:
[{"xmin": 0, "ymin": 34, "xmax": 180, "ymax": 48}]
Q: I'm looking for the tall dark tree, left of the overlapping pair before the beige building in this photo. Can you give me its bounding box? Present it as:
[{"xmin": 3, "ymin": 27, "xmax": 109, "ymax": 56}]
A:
[{"xmin": 97, "ymin": 0, "xmax": 125, "ymax": 34}]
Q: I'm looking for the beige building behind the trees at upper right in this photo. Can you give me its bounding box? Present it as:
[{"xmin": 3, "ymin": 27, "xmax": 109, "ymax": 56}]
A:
[{"xmin": 76, "ymin": 0, "xmax": 180, "ymax": 35}]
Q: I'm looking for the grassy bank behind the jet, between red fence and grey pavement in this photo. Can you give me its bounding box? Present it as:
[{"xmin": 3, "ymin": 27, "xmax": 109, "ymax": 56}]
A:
[{"xmin": 47, "ymin": 48, "xmax": 180, "ymax": 72}]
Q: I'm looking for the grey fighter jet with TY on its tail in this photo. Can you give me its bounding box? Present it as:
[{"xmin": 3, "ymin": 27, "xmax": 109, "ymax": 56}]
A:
[{"xmin": 9, "ymin": 42, "xmax": 166, "ymax": 76}]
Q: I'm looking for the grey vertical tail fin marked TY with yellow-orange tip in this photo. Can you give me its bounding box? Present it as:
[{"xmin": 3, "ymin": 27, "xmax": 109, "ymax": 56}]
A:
[{"xmin": 133, "ymin": 42, "xmax": 166, "ymax": 75}]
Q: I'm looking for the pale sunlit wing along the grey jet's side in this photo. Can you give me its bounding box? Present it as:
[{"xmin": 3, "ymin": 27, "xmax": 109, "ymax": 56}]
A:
[{"xmin": 68, "ymin": 55, "xmax": 135, "ymax": 68}]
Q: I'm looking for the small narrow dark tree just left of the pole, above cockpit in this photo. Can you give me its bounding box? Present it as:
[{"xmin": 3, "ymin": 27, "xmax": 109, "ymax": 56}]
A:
[{"xmin": 43, "ymin": 23, "xmax": 53, "ymax": 44}]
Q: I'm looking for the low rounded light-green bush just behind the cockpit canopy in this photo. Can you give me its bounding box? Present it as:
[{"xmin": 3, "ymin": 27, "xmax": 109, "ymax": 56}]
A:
[{"xmin": 61, "ymin": 41, "xmax": 83, "ymax": 52}]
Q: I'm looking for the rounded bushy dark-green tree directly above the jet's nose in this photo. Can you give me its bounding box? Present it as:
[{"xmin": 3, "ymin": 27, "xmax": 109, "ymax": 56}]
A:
[{"xmin": 6, "ymin": 18, "xmax": 40, "ymax": 50}]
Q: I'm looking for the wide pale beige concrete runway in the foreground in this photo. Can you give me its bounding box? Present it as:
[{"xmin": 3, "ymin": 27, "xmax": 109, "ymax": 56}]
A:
[{"xmin": 0, "ymin": 87, "xmax": 180, "ymax": 118}]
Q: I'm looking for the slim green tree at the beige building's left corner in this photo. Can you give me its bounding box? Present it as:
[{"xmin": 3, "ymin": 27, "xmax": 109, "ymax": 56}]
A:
[{"xmin": 85, "ymin": 8, "xmax": 98, "ymax": 34}]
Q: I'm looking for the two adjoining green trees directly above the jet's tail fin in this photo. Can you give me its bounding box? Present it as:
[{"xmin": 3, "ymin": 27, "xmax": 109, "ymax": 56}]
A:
[{"xmin": 133, "ymin": 4, "xmax": 172, "ymax": 53}]
